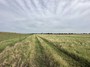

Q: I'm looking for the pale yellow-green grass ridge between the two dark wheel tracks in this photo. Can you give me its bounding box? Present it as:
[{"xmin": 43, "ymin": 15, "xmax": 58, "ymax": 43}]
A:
[{"xmin": 38, "ymin": 37, "xmax": 70, "ymax": 67}]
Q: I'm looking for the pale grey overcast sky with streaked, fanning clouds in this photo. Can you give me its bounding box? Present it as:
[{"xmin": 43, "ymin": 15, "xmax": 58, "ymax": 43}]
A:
[{"xmin": 0, "ymin": 0, "xmax": 90, "ymax": 33}]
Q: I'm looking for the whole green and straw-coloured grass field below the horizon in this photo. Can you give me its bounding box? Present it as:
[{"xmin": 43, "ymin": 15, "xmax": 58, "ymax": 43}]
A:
[{"xmin": 0, "ymin": 33, "xmax": 90, "ymax": 67}]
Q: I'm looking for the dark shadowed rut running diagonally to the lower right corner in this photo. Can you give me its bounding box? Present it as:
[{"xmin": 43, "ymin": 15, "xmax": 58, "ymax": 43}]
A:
[{"xmin": 41, "ymin": 37, "xmax": 90, "ymax": 67}]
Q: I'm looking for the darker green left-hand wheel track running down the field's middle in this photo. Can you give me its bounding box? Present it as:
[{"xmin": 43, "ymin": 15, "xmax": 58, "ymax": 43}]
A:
[{"xmin": 35, "ymin": 37, "xmax": 60, "ymax": 67}]
